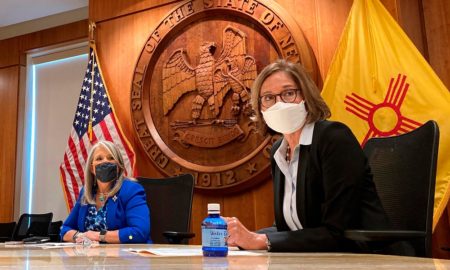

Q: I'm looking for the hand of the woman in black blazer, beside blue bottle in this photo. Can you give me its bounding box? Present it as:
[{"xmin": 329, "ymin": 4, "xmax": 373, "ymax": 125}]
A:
[{"xmin": 224, "ymin": 217, "xmax": 267, "ymax": 250}]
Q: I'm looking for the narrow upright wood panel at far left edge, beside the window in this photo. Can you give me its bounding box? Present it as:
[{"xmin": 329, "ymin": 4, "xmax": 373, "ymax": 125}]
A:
[{"xmin": 0, "ymin": 65, "xmax": 19, "ymax": 222}]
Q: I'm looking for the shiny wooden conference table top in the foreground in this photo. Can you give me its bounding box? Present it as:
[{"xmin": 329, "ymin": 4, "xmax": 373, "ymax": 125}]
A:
[{"xmin": 0, "ymin": 243, "xmax": 450, "ymax": 270}]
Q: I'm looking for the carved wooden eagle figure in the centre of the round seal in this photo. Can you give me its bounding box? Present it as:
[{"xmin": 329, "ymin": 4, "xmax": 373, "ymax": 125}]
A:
[{"xmin": 162, "ymin": 25, "xmax": 257, "ymax": 124}]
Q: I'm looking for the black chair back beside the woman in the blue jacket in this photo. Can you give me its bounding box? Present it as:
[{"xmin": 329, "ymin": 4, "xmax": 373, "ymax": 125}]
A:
[{"xmin": 137, "ymin": 174, "xmax": 194, "ymax": 244}]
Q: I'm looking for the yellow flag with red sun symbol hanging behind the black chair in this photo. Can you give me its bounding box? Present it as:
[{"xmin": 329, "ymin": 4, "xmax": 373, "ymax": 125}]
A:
[{"xmin": 322, "ymin": 0, "xmax": 450, "ymax": 229}]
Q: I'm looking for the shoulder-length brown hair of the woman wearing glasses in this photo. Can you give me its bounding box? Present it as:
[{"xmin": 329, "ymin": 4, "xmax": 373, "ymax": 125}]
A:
[{"xmin": 251, "ymin": 59, "xmax": 331, "ymax": 130}]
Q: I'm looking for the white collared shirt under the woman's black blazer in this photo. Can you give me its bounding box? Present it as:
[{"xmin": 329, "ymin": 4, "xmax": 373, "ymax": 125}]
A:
[{"xmin": 274, "ymin": 123, "xmax": 315, "ymax": 231}]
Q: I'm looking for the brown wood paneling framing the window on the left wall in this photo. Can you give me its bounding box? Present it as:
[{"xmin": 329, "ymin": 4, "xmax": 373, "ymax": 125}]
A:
[{"xmin": 0, "ymin": 20, "xmax": 88, "ymax": 222}]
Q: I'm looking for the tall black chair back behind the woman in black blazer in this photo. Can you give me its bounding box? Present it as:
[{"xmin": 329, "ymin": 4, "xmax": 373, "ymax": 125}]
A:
[{"xmin": 364, "ymin": 121, "xmax": 439, "ymax": 257}]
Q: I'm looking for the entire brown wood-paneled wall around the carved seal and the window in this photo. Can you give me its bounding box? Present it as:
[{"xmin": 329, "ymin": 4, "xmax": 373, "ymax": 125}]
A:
[{"xmin": 0, "ymin": 0, "xmax": 450, "ymax": 256}]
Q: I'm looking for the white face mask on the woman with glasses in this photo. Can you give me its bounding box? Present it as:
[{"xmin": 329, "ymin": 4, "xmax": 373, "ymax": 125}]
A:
[{"xmin": 261, "ymin": 100, "xmax": 308, "ymax": 134}]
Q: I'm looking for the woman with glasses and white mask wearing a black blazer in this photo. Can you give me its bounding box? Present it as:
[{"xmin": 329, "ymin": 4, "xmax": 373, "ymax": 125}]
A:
[{"xmin": 226, "ymin": 60, "xmax": 388, "ymax": 252}]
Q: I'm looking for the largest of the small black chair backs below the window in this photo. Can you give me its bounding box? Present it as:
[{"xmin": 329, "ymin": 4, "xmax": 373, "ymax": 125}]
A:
[{"xmin": 13, "ymin": 213, "xmax": 53, "ymax": 241}]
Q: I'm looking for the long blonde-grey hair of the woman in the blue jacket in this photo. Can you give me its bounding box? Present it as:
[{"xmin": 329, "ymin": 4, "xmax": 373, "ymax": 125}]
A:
[{"xmin": 81, "ymin": 141, "xmax": 132, "ymax": 204}]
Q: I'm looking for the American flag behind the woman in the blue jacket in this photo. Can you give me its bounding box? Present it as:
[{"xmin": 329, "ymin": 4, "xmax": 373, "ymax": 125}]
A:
[{"xmin": 59, "ymin": 45, "xmax": 135, "ymax": 209}]
